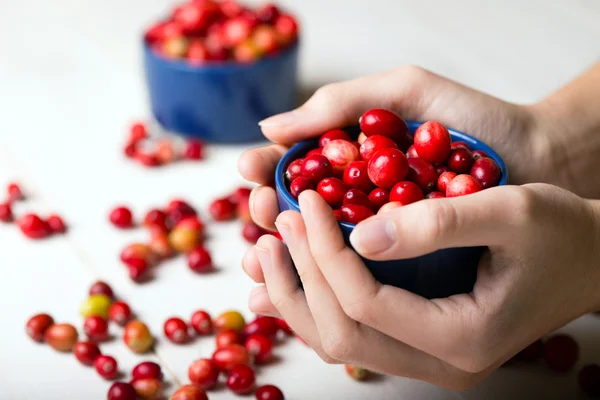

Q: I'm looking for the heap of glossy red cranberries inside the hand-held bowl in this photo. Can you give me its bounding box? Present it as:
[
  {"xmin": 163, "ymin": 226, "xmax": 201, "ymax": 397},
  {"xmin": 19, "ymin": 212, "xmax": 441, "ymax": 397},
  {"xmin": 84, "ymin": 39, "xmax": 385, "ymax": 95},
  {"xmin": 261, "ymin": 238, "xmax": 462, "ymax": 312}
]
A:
[{"xmin": 285, "ymin": 109, "xmax": 502, "ymax": 223}]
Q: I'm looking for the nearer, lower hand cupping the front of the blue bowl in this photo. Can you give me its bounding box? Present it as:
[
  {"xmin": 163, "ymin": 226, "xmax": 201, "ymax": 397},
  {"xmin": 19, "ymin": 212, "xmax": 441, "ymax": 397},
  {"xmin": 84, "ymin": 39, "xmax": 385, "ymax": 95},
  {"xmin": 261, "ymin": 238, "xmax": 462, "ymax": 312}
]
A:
[{"xmin": 244, "ymin": 184, "xmax": 600, "ymax": 390}]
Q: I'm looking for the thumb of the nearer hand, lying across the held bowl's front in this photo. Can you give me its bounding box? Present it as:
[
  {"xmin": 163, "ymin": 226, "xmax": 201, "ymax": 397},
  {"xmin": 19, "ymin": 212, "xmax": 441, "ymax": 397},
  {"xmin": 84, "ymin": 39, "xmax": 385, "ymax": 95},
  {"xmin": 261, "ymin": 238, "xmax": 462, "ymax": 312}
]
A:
[{"xmin": 350, "ymin": 186, "xmax": 525, "ymax": 260}]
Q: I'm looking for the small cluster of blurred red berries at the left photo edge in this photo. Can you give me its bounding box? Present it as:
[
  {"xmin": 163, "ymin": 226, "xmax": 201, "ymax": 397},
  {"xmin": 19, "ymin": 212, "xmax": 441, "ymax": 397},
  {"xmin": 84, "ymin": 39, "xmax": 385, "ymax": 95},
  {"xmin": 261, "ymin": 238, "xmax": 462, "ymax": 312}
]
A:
[{"xmin": 0, "ymin": 183, "xmax": 67, "ymax": 239}]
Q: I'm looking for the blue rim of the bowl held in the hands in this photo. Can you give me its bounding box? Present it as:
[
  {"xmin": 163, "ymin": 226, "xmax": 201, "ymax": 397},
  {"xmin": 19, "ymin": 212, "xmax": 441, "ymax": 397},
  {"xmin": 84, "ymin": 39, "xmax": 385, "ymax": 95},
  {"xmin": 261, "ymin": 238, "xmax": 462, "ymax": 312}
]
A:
[{"xmin": 275, "ymin": 121, "xmax": 508, "ymax": 229}]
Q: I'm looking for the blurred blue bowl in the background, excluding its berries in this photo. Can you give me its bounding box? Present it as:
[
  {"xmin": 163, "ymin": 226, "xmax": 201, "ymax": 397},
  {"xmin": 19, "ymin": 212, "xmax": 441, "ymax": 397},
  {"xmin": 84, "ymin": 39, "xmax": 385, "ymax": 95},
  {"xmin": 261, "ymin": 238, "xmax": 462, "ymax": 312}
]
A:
[{"xmin": 143, "ymin": 42, "xmax": 298, "ymax": 143}]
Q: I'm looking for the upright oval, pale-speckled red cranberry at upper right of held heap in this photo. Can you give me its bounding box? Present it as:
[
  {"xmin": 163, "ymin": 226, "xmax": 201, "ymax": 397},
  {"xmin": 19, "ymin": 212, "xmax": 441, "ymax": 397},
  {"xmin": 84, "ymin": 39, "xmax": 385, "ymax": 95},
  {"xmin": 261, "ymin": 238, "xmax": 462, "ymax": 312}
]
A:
[{"xmin": 414, "ymin": 121, "xmax": 452, "ymax": 164}]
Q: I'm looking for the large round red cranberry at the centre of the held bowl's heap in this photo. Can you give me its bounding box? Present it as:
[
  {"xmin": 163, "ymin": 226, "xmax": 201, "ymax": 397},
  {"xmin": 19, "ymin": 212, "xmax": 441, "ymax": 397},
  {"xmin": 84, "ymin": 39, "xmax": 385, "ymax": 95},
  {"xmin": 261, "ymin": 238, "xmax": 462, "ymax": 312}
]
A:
[{"xmin": 369, "ymin": 149, "xmax": 408, "ymax": 189}]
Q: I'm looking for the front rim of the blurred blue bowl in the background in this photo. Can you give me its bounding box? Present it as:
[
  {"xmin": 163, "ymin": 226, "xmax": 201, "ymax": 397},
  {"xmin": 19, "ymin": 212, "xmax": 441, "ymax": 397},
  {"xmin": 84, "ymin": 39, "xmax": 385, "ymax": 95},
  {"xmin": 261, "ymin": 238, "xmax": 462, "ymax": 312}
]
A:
[{"xmin": 142, "ymin": 38, "xmax": 300, "ymax": 73}]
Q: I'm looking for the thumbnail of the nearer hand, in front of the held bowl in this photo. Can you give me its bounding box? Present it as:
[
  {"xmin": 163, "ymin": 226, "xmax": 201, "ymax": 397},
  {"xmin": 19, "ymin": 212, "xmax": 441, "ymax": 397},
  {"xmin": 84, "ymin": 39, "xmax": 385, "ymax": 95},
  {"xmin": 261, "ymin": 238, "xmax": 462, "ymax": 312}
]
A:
[{"xmin": 350, "ymin": 218, "xmax": 396, "ymax": 254}]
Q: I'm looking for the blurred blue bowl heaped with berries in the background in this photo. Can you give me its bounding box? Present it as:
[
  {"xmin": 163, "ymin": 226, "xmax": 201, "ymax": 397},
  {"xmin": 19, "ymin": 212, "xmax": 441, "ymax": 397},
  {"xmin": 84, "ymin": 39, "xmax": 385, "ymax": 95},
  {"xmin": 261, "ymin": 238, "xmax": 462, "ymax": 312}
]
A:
[{"xmin": 142, "ymin": 0, "xmax": 299, "ymax": 143}]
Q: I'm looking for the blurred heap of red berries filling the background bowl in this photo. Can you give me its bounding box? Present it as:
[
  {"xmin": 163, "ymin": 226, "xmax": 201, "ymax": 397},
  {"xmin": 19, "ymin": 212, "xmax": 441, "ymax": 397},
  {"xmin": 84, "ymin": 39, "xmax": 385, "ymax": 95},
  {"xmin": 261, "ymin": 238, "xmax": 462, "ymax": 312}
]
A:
[{"xmin": 145, "ymin": 0, "xmax": 298, "ymax": 66}]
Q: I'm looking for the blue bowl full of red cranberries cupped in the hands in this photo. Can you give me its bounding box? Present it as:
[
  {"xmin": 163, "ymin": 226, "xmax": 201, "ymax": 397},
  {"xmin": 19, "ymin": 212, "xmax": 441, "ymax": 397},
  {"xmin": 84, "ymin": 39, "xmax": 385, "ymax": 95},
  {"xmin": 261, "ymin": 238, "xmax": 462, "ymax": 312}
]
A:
[{"xmin": 275, "ymin": 110, "xmax": 508, "ymax": 298}]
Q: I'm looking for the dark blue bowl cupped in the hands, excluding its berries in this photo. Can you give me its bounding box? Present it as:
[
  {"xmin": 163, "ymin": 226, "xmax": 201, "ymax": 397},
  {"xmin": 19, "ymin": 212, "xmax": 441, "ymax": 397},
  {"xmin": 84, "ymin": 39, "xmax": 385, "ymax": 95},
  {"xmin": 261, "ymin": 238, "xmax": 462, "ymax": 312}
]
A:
[{"xmin": 275, "ymin": 122, "xmax": 508, "ymax": 299}]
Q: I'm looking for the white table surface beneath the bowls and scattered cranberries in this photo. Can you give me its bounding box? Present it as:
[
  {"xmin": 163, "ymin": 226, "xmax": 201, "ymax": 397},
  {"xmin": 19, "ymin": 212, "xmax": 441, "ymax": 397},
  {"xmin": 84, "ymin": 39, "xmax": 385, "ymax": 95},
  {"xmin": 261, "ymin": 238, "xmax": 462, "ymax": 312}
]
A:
[{"xmin": 0, "ymin": 0, "xmax": 600, "ymax": 400}]
